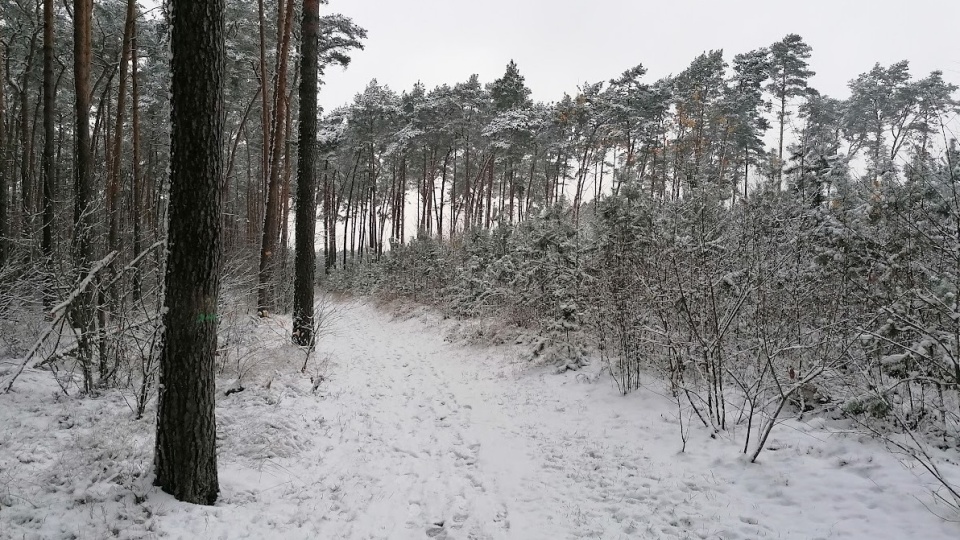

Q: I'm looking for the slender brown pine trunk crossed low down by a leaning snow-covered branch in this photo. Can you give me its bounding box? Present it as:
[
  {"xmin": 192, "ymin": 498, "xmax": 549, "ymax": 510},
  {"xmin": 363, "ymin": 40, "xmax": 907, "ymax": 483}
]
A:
[{"xmin": 71, "ymin": 0, "xmax": 94, "ymax": 392}]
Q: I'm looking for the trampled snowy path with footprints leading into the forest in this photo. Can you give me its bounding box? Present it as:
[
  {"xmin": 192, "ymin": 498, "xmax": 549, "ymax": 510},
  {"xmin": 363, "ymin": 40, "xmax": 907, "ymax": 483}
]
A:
[{"xmin": 300, "ymin": 304, "xmax": 704, "ymax": 539}]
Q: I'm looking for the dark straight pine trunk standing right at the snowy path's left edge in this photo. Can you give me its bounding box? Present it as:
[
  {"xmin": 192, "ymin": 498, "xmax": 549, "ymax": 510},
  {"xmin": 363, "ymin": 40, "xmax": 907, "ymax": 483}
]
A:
[{"xmin": 293, "ymin": 0, "xmax": 320, "ymax": 345}]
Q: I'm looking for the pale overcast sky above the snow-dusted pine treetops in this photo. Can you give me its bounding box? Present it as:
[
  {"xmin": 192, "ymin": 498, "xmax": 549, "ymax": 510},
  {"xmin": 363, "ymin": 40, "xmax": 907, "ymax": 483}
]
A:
[{"xmin": 320, "ymin": 0, "xmax": 960, "ymax": 110}]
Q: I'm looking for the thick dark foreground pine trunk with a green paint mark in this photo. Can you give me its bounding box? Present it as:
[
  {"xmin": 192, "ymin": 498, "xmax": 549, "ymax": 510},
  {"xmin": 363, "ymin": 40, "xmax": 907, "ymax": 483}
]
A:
[{"xmin": 155, "ymin": 0, "xmax": 224, "ymax": 504}]
